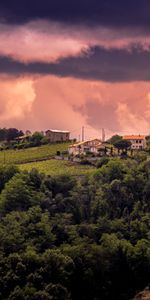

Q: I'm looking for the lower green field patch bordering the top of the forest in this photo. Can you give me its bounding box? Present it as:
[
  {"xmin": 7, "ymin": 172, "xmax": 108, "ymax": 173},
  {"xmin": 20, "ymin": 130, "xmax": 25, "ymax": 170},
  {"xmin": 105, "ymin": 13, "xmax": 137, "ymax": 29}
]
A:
[{"xmin": 19, "ymin": 159, "xmax": 95, "ymax": 176}]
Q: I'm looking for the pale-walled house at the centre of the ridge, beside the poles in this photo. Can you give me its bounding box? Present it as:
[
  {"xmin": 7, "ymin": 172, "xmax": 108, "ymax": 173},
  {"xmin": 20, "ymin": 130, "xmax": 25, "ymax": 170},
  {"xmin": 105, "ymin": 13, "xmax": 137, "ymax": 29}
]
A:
[{"xmin": 68, "ymin": 139, "xmax": 102, "ymax": 155}]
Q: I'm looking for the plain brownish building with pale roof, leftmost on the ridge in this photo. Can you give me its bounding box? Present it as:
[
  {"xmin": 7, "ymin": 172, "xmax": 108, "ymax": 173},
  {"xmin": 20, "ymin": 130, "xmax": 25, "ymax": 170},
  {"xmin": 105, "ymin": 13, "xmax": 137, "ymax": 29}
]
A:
[{"xmin": 45, "ymin": 129, "xmax": 70, "ymax": 143}]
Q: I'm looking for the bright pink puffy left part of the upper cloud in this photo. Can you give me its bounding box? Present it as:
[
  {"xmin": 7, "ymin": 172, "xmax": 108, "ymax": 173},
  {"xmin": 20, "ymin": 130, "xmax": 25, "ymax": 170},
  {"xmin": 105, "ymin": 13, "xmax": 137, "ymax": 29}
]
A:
[{"xmin": 0, "ymin": 22, "xmax": 87, "ymax": 62}]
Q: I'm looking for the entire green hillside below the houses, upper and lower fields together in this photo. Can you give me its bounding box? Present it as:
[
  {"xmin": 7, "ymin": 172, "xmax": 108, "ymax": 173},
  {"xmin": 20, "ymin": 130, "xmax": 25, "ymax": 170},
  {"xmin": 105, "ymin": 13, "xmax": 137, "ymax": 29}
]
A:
[{"xmin": 0, "ymin": 143, "xmax": 93, "ymax": 175}]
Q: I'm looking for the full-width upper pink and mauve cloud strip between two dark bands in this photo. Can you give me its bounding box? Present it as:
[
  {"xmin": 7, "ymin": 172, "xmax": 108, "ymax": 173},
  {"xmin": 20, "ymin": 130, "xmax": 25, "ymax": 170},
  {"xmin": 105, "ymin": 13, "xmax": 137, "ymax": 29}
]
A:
[{"xmin": 0, "ymin": 20, "xmax": 150, "ymax": 62}]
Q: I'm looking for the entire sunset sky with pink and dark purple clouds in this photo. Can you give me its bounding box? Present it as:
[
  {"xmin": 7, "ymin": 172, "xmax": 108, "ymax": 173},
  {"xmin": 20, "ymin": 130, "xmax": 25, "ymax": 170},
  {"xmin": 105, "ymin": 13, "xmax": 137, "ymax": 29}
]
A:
[{"xmin": 0, "ymin": 0, "xmax": 150, "ymax": 138}]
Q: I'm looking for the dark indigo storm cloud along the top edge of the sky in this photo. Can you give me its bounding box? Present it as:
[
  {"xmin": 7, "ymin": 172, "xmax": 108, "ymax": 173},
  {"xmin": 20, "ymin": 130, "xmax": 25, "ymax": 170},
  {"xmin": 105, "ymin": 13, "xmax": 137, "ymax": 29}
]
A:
[{"xmin": 0, "ymin": 0, "xmax": 150, "ymax": 28}]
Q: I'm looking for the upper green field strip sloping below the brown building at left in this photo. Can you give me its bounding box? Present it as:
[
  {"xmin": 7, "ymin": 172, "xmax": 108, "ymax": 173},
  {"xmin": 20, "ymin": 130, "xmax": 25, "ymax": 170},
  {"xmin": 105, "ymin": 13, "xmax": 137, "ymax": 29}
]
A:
[{"xmin": 0, "ymin": 143, "xmax": 69, "ymax": 164}]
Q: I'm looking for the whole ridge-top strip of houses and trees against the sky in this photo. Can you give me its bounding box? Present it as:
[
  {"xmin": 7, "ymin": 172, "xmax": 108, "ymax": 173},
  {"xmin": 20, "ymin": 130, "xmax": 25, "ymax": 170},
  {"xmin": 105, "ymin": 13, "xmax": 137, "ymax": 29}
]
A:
[{"xmin": 0, "ymin": 128, "xmax": 150, "ymax": 157}]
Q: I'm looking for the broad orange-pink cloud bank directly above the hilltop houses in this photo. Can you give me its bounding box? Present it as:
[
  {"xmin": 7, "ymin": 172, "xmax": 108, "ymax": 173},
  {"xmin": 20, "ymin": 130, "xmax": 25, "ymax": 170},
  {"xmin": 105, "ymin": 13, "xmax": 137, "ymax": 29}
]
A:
[{"xmin": 0, "ymin": 76, "xmax": 150, "ymax": 138}]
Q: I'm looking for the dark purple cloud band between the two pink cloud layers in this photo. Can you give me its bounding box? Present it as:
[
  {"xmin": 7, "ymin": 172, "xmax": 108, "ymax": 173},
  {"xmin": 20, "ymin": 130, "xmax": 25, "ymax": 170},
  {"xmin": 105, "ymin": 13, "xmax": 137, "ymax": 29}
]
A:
[{"xmin": 0, "ymin": 47, "xmax": 150, "ymax": 82}]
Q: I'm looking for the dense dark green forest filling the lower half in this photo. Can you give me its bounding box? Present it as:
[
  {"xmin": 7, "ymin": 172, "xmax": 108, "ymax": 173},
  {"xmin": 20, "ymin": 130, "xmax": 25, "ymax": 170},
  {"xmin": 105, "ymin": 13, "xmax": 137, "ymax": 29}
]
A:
[{"xmin": 0, "ymin": 159, "xmax": 150, "ymax": 300}]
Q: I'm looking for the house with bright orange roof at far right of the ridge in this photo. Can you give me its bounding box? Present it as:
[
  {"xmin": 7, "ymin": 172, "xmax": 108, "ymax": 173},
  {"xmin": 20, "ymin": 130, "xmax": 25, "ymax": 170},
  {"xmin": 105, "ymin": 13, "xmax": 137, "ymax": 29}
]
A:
[{"xmin": 123, "ymin": 135, "xmax": 146, "ymax": 150}]
